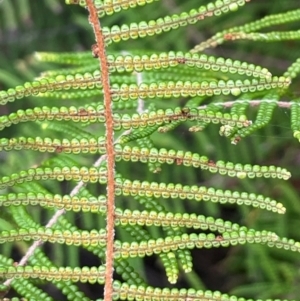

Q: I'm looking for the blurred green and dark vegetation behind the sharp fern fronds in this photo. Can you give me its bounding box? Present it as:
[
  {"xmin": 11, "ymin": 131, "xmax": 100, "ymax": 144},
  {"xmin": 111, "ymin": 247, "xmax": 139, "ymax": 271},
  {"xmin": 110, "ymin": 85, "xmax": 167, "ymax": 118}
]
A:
[{"xmin": 0, "ymin": 0, "xmax": 300, "ymax": 299}]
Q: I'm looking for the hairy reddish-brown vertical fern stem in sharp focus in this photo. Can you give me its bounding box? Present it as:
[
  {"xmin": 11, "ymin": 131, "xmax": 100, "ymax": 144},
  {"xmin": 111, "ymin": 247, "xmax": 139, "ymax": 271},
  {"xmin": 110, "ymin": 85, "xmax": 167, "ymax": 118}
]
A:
[{"xmin": 86, "ymin": 0, "xmax": 115, "ymax": 301}]
